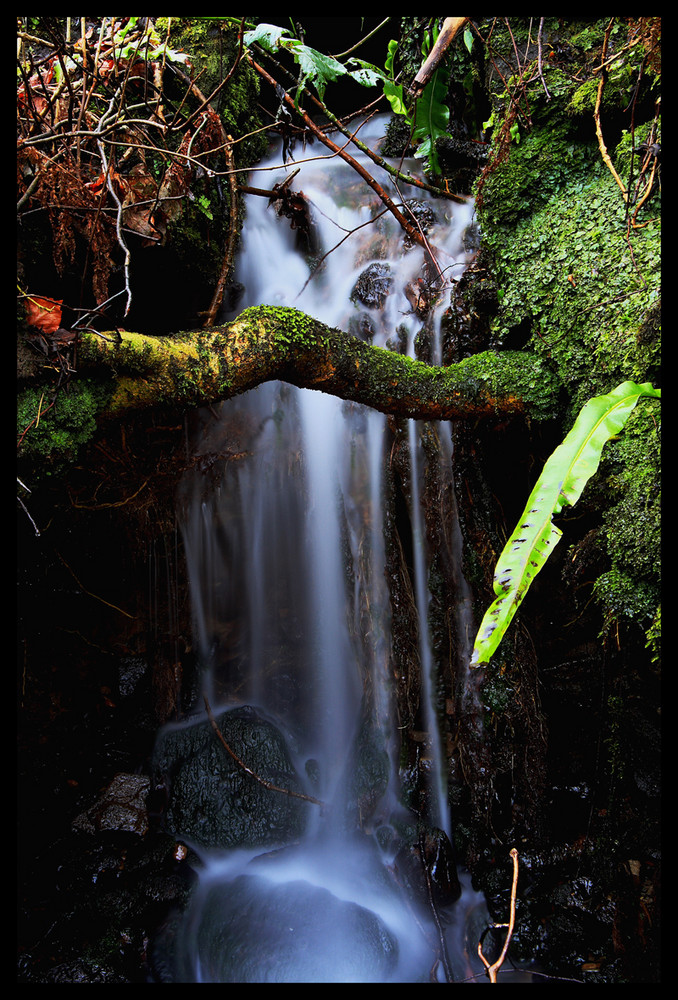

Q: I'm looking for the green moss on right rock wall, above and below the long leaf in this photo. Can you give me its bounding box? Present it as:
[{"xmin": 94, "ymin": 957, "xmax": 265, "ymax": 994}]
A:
[{"xmin": 479, "ymin": 18, "xmax": 661, "ymax": 644}]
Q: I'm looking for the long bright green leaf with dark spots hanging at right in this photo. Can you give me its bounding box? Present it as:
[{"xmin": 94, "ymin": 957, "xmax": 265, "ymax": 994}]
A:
[{"xmin": 471, "ymin": 382, "xmax": 661, "ymax": 667}]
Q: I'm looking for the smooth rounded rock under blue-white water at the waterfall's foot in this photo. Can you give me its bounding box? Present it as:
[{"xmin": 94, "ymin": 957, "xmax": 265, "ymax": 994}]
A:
[{"xmin": 160, "ymin": 875, "xmax": 398, "ymax": 983}]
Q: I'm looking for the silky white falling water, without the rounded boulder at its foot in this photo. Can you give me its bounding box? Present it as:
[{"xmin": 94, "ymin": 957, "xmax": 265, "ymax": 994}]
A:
[{"xmin": 170, "ymin": 119, "xmax": 482, "ymax": 981}]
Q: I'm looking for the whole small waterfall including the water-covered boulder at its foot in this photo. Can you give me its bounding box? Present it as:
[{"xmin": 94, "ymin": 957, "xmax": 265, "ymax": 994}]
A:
[{"xmin": 157, "ymin": 119, "xmax": 492, "ymax": 982}]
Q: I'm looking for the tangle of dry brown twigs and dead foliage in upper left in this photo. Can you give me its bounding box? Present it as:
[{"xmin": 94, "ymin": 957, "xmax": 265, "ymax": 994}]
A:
[{"xmin": 17, "ymin": 17, "xmax": 242, "ymax": 315}]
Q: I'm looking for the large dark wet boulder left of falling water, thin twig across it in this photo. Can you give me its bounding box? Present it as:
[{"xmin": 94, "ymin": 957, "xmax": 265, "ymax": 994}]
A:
[{"xmin": 153, "ymin": 706, "xmax": 310, "ymax": 848}]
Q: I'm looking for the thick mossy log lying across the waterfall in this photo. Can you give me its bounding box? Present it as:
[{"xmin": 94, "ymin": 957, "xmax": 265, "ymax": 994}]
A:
[{"xmin": 78, "ymin": 306, "xmax": 558, "ymax": 419}]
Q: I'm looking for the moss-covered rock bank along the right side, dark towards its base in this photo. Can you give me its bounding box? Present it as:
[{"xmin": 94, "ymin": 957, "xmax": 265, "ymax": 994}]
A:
[{"xmin": 455, "ymin": 18, "xmax": 661, "ymax": 982}]
